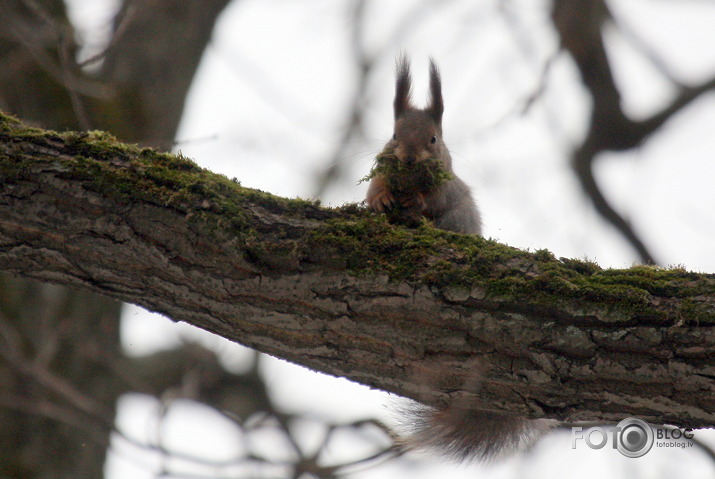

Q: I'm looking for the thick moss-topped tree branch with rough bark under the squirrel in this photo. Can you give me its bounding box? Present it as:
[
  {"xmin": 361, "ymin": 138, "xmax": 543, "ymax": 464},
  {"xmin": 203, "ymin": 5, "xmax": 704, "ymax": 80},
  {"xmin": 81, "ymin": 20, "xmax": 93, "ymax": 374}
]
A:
[{"xmin": 0, "ymin": 112, "xmax": 715, "ymax": 427}]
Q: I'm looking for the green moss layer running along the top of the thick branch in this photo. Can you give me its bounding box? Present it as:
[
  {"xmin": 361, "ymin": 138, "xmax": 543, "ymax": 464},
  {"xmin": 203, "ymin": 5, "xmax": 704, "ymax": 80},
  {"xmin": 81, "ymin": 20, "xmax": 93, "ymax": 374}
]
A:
[{"xmin": 0, "ymin": 115, "xmax": 715, "ymax": 325}]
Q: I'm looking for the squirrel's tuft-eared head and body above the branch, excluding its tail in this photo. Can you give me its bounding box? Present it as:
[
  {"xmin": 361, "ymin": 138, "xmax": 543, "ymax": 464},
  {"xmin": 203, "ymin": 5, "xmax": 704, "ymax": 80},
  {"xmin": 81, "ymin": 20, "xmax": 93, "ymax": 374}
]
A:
[{"xmin": 366, "ymin": 55, "xmax": 482, "ymax": 235}]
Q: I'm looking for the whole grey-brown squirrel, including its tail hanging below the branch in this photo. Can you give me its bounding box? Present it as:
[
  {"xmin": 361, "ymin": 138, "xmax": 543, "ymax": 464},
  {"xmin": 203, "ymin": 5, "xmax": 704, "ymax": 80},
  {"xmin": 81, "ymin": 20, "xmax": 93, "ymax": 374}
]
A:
[{"xmin": 366, "ymin": 55, "xmax": 557, "ymax": 462}]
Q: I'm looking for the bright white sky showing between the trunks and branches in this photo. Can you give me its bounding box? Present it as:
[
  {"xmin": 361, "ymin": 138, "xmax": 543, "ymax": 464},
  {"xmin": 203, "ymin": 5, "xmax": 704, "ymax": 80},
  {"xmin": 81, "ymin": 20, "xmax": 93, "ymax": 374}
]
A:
[{"xmin": 61, "ymin": 0, "xmax": 715, "ymax": 479}]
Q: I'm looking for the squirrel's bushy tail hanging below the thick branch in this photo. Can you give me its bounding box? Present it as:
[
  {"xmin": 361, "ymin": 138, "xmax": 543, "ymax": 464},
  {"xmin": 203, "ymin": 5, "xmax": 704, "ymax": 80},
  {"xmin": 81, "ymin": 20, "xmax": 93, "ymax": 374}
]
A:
[{"xmin": 400, "ymin": 403, "xmax": 558, "ymax": 462}]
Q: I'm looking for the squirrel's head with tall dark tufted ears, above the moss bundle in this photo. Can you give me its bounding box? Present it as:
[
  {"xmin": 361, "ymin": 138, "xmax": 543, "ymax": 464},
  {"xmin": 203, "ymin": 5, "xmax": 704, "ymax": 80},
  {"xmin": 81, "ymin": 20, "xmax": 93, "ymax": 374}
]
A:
[{"xmin": 388, "ymin": 56, "xmax": 451, "ymax": 168}]
